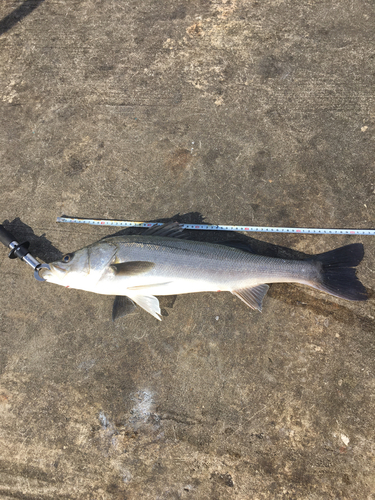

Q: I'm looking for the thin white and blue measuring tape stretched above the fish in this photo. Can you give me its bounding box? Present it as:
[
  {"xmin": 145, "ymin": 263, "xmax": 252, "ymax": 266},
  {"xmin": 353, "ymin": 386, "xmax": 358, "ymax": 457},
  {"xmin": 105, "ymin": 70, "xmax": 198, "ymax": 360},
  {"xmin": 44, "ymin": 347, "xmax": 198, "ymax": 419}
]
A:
[{"xmin": 56, "ymin": 217, "xmax": 375, "ymax": 236}]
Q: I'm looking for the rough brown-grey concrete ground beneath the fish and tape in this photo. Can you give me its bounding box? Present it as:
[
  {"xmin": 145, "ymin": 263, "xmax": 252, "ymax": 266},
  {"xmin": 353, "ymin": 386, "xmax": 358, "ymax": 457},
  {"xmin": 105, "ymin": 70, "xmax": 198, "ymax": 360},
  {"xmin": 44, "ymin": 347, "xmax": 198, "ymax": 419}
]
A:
[{"xmin": 0, "ymin": 0, "xmax": 375, "ymax": 500}]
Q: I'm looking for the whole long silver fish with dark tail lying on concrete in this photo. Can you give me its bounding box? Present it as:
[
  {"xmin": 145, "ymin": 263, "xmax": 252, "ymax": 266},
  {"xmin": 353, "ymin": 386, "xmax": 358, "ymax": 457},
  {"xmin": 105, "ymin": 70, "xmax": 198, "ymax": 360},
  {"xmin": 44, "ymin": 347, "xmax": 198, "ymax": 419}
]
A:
[{"xmin": 39, "ymin": 222, "xmax": 368, "ymax": 320}]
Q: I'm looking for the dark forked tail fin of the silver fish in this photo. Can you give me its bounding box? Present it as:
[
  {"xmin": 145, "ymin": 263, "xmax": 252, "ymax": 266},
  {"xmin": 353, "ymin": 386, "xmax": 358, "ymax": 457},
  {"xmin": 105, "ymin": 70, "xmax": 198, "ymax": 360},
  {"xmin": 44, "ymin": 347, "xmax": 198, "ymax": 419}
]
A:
[{"xmin": 309, "ymin": 243, "xmax": 368, "ymax": 300}]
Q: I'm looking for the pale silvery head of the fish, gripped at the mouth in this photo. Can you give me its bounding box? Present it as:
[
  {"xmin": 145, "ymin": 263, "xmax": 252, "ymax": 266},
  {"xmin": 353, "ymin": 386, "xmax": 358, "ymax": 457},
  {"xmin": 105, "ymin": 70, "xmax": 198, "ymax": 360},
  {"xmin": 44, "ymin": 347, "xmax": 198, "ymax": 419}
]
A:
[{"xmin": 39, "ymin": 247, "xmax": 90, "ymax": 288}]
